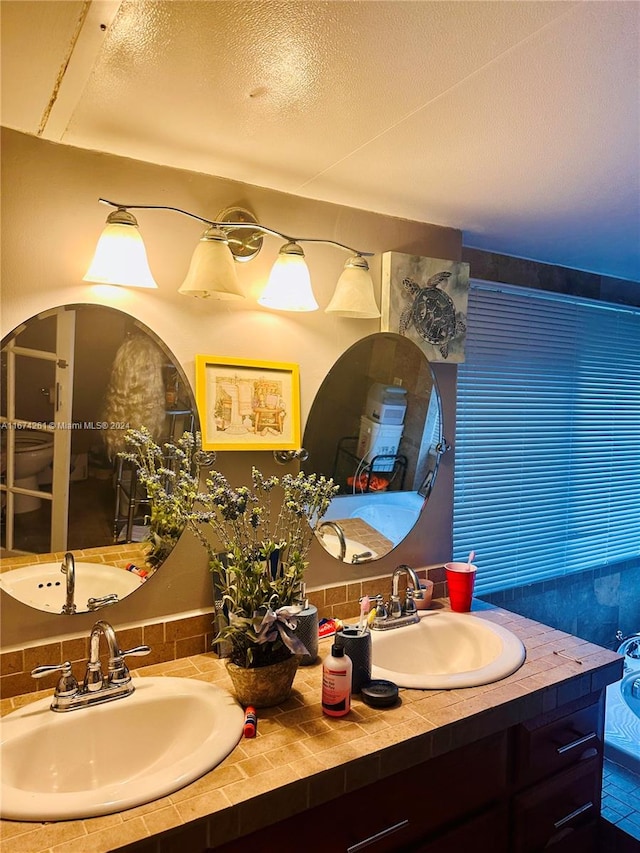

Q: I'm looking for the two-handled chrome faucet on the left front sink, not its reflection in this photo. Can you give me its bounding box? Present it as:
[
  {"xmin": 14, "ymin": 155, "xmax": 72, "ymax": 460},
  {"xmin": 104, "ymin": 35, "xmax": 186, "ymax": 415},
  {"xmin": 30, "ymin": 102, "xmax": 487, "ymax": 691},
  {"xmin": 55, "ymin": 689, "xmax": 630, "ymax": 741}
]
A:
[{"xmin": 31, "ymin": 619, "xmax": 151, "ymax": 711}]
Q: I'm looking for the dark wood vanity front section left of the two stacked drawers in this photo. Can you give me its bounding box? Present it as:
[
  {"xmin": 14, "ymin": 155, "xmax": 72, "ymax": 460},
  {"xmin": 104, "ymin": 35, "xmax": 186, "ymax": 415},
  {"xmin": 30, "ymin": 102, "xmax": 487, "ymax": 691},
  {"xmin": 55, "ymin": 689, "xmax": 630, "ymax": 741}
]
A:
[{"xmin": 216, "ymin": 732, "xmax": 508, "ymax": 853}]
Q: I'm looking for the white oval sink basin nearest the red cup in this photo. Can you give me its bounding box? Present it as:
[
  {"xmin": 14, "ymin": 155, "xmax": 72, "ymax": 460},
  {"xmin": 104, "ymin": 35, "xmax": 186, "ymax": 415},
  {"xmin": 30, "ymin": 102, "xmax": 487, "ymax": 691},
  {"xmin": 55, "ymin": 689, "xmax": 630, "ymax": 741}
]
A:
[{"xmin": 371, "ymin": 610, "xmax": 525, "ymax": 690}]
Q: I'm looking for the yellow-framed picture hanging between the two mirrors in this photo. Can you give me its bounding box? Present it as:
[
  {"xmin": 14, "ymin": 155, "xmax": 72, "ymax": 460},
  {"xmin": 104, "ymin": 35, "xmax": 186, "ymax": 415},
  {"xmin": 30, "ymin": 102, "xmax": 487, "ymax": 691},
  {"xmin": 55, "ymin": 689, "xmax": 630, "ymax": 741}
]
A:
[{"xmin": 196, "ymin": 355, "xmax": 300, "ymax": 450}]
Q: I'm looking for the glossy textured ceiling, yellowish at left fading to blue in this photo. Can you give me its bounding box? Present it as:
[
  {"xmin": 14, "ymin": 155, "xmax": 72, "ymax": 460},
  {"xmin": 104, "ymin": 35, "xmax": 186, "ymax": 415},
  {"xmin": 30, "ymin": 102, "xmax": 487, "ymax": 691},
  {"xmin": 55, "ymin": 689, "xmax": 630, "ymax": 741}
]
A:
[{"xmin": 0, "ymin": 0, "xmax": 640, "ymax": 280}]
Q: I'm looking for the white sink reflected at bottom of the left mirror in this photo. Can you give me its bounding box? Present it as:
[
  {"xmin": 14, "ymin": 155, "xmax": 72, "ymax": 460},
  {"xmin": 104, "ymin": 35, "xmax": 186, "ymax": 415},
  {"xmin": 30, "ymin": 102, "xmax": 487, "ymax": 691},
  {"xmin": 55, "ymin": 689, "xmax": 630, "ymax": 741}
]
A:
[{"xmin": 0, "ymin": 560, "xmax": 143, "ymax": 613}]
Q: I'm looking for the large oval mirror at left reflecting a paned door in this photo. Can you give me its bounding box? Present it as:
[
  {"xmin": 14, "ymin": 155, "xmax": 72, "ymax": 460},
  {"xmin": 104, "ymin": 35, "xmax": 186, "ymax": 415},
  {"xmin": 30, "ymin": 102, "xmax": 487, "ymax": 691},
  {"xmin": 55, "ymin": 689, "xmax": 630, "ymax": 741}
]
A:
[{"xmin": 0, "ymin": 304, "xmax": 197, "ymax": 613}]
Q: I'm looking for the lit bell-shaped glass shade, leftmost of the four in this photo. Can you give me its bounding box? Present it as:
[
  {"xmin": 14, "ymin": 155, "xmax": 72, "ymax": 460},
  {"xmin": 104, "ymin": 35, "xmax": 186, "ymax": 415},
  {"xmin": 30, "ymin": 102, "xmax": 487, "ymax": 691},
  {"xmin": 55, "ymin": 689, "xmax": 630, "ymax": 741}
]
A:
[{"xmin": 83, "ymin": 210, "xmax": 158, "ymax": 288}]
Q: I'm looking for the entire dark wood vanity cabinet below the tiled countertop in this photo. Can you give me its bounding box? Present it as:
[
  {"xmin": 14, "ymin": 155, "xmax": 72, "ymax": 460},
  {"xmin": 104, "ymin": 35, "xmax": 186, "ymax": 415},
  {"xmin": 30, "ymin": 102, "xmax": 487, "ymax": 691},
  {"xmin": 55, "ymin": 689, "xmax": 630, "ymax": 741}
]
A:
[{"xmin": 210, "ymin": 694, "xmax": 604, "ymax": 853}]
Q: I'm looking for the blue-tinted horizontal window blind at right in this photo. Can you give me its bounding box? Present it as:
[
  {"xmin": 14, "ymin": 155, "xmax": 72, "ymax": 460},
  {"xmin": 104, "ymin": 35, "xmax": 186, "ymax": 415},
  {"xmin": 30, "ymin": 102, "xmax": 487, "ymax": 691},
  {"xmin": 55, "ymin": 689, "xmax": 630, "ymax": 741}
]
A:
[{"xmin": 453, "ymin": 282, "xmax": 640, "ymax": 593}]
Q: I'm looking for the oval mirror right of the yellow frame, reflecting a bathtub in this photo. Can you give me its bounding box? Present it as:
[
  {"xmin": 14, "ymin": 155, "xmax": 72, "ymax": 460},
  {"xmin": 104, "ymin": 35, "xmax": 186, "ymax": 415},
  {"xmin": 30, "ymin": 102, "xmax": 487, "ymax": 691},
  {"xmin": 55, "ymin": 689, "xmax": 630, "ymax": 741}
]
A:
[{"xmin": 302, "ymin": 332, "xmax": 444, "ymax": 563}]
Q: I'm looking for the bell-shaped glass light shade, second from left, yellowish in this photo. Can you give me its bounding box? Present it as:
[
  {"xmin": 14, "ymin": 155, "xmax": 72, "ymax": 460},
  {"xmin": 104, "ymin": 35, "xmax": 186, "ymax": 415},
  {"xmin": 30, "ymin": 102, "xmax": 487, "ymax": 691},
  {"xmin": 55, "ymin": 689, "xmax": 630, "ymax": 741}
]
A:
[{"xmin": 178, "ymin": 226, "xmax": 245, "ymax": 300}]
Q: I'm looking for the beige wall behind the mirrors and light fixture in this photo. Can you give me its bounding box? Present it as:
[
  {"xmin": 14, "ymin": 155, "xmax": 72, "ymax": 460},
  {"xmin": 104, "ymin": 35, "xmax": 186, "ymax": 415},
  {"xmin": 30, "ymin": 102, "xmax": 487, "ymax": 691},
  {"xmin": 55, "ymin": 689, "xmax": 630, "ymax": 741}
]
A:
[{"xmin": 0, "ymin": 129, "xmax": 462, "ymax": 648}]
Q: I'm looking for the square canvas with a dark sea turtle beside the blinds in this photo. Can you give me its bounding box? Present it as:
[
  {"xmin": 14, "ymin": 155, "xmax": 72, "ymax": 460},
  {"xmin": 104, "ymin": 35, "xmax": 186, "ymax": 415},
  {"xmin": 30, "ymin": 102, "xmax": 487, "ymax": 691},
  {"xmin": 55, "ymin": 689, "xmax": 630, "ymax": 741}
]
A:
[{"xmin": 382, "ymin": 252, "xmax": 469, "ymax": 363}]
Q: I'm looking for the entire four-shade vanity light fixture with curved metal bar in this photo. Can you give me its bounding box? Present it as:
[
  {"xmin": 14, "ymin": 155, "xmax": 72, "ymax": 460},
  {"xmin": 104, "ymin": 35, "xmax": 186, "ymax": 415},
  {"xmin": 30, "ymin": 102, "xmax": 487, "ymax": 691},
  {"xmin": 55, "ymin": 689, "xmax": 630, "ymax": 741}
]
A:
[{"xmin": 84, "ymin": 198, "xmax": 380, "ymax": 319}]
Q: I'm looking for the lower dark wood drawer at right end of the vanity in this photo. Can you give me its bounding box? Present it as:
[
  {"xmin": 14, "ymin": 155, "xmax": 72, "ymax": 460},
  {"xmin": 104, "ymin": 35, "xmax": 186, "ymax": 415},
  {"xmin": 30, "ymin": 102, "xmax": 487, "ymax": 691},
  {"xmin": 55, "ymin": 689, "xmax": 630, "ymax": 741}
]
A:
[{"xmin": 514, "ymin": 759, "xmax": 601, "ymax": 853}]
